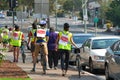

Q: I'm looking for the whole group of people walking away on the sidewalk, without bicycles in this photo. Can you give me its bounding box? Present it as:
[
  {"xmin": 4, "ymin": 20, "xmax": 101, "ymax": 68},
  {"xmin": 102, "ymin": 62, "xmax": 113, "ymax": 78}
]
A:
[{"xmin": 1, "ymin": 20, "xmax": 77, "ymax": 76}]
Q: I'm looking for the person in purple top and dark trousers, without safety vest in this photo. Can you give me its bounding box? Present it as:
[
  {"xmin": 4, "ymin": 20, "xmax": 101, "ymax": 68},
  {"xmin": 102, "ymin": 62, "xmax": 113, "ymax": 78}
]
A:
[{"xmin": 48, "ymin": 27, "xmax": 59, "ymax": 70}]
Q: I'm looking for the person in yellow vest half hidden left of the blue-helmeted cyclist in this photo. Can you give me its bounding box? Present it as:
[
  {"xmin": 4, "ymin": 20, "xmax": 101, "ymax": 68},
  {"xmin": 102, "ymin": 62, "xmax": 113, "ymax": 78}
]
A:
[{"xmin": 28, "ymin": 23, "xmax": 37, "ymax": 62}]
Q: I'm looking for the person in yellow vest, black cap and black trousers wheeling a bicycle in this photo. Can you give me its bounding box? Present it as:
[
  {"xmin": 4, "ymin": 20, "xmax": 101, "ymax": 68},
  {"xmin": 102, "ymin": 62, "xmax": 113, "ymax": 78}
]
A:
[{"xmin": 57, "ymin": 23, "xmax": 78, "ymax": 76}]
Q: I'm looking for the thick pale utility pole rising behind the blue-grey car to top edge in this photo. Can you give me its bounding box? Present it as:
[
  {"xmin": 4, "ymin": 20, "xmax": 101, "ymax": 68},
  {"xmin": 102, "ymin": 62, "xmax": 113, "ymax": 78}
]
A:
[{"xmin": 82, "ymin": 0, "xmax": 88, "ymax": 33}]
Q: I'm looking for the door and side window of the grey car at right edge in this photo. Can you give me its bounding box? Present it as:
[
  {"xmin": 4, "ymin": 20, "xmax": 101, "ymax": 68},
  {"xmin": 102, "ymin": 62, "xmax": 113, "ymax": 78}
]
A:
[{"xmin": 109, "ymin": 41, "xmax": 120, "ymax": 78}]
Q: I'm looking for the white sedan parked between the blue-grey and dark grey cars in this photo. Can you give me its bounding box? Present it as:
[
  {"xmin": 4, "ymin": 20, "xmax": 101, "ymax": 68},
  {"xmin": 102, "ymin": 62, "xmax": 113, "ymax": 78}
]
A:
[{"xmin": 80, "ymin": 36, "xmax": 120, "ymax": 72}]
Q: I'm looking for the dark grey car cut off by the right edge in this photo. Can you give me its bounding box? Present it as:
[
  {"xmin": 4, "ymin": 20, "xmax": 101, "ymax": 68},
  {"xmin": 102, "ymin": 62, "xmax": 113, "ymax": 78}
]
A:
[{"xmin": 105, "ymin": 40, "xmax": 120, "ymax": 80}]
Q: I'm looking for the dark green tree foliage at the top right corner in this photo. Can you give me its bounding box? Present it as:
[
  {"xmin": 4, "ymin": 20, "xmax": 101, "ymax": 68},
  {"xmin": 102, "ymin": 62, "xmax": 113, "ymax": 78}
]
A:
[{"xmin": 106, "ymin": 0, "xmax": 120, "ymax": 27}]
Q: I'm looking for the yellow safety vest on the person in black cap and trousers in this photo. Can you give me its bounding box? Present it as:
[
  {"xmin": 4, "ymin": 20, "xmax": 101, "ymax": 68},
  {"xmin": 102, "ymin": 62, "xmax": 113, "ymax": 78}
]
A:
[{"xmin": 58, "ymin": 31, "xmax": 72, "ymax": 50}]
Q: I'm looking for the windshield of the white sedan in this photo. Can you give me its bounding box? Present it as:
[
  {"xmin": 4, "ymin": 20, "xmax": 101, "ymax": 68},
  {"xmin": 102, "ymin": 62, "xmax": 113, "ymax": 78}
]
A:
[{"xmin": 92, "ymin": 39, "xmax": 119, "ymax": 49}]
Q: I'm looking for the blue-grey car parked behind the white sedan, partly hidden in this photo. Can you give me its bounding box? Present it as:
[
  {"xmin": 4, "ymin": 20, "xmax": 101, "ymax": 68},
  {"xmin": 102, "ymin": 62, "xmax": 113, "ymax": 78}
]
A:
[{"xmin": 69, "ymin": 33, "xmax": 94, "ymax": 65}]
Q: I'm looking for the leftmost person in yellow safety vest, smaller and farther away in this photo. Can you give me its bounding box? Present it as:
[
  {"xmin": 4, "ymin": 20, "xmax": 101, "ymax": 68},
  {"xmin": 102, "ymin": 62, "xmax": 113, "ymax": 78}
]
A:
[{"xmin": 2, "ymin": 26, "xmax": 9, "ymax": 48}]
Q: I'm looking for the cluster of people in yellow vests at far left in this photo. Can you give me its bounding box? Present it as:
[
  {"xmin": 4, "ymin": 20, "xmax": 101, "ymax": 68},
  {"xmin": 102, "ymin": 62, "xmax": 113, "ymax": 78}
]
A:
[{"xmin": 0, "ymin": 24, "xmax": 24, "ymax": 62}]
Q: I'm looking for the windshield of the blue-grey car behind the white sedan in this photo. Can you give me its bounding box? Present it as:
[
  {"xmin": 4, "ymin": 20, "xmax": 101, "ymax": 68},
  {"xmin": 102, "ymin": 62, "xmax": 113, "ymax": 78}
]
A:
[{"xmin": 73, "ymin": 36, "xmax": 92, "ymax": 44}]
